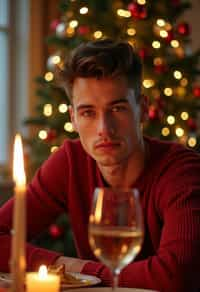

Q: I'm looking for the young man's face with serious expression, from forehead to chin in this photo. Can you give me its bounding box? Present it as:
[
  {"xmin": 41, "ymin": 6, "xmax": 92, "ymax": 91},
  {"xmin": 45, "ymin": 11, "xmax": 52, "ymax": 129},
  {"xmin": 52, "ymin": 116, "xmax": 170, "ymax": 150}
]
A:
[{"xmin": 71, "ymin": 78, "xmax": 142, "ymax": 166}]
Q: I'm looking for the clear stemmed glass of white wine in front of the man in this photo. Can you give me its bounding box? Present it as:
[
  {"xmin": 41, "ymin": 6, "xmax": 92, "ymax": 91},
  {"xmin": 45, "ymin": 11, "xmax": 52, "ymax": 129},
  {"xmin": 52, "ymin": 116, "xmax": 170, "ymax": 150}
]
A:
[{"xmin": 88, "ymin": 188, "xmax": 143, "ymax": 290}]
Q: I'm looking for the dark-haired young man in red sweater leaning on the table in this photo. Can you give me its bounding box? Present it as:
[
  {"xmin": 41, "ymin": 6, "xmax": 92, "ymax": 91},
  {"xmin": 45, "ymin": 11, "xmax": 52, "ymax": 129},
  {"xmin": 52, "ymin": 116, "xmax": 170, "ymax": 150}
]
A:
[{"xmin": 0, "ymin": 40, "xmax": 200, "ymax": 292}]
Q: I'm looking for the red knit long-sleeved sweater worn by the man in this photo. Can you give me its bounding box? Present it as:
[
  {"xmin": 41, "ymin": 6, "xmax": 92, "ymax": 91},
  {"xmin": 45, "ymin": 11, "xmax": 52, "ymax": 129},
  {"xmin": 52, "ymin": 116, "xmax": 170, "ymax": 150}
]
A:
[{"xmin": 0, "ymin": 137, "xmax": 200, "ymax": 292}]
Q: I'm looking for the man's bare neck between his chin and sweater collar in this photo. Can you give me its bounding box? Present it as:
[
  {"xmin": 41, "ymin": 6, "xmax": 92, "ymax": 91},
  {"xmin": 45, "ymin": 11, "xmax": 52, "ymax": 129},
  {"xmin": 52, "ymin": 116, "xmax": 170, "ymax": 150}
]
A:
[{"xmin": 99, "ymin": 142, "xmax": 148, "ymax": 188}]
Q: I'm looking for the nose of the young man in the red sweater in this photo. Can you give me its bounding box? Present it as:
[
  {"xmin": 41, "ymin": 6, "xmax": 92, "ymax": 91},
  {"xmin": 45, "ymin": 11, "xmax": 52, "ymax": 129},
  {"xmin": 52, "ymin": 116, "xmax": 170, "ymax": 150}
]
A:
[{"xmin": 97, "ymin": 113, "xmax": 116, "ymax": 138}]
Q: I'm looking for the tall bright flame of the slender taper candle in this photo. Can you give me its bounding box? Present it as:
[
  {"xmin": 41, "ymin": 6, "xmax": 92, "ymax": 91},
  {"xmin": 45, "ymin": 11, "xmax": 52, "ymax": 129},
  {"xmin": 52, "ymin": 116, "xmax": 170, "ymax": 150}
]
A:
[{"xmin": 13, "ymin": 134, "xmax": 26, "ymax": 186}]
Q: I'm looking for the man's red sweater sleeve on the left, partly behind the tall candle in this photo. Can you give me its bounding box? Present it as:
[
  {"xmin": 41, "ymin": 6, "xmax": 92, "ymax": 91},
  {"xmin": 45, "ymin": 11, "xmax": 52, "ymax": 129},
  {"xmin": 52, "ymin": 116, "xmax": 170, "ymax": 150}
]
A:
[{"xmin": 0, "ymin": 141, "xmax": 67, "ymax": 272}]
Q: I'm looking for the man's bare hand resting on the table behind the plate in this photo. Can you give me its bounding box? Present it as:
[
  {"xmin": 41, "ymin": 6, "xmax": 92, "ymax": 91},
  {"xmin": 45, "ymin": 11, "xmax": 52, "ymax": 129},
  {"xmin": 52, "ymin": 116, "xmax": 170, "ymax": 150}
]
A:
[{"xmin": 54, "ymin": 256, "xmax": 89, "ymax": 273}]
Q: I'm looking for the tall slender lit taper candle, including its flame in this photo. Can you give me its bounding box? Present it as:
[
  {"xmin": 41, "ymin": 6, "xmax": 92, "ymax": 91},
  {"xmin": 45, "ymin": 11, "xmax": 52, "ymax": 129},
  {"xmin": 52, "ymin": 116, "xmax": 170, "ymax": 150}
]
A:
[{"xmin": 11, "ymin": 134, "xmax": 26, "ymax": 292}]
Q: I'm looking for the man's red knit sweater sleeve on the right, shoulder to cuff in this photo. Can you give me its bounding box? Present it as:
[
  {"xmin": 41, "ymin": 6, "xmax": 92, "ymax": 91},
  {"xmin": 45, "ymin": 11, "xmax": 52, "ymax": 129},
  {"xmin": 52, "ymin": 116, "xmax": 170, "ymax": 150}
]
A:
[{"xmin": 83, "ymin": 148, "xmax": 200, "ymax": 292}]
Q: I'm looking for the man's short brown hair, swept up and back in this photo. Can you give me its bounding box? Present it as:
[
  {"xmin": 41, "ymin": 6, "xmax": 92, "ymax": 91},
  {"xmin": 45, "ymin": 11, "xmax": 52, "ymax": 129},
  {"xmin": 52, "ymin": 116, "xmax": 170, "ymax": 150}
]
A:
[{"xmin": 59, "ymin": 39, "xmax": 142, "ymax": 101}]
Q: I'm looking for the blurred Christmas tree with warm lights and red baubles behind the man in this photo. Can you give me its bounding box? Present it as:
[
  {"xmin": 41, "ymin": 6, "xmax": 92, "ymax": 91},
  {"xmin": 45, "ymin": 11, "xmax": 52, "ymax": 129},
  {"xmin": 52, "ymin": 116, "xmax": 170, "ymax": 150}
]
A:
[{"xmin": 26, "ymin": 0, "xmax": 200, "ymax": 254}]
